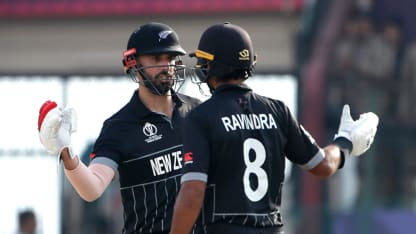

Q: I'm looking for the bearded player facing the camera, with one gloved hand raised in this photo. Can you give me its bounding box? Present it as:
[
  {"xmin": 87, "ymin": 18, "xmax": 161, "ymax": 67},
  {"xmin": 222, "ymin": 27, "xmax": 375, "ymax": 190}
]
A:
[{"xmin": 38, "ymin": 22, "xmax": 200, "ymax": 234}]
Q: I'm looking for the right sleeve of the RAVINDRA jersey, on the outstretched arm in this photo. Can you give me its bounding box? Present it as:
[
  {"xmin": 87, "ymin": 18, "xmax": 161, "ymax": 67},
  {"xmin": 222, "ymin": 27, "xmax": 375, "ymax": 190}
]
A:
[{"xmin": 285, "ymin": 104, "xmax": 325, "ymax": 170}]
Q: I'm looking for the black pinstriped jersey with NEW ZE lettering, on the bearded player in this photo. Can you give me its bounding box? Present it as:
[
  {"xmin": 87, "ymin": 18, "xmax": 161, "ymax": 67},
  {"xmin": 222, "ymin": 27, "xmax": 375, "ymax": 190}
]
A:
[{"xmin": 91, "ymin": 88, "xmax": 200, "ymax": 233}]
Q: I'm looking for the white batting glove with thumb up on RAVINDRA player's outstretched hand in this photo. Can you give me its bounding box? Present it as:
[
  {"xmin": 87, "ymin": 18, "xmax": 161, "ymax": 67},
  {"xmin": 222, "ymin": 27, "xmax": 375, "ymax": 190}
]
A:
[{"xmin": 334, "ymin": 105, "xmax": 379, "ymax": 157}]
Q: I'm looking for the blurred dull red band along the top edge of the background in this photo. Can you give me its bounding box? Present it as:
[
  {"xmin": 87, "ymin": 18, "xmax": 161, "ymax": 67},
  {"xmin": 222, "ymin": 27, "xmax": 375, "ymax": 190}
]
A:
[{"xmin": 0, "ymin": 0, "xmax": 303, "ymax": 18}]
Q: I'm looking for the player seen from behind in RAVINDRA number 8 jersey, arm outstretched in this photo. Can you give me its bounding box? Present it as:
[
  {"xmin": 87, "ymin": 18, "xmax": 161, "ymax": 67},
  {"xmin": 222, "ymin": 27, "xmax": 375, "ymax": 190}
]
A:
[{"xmin": 171, "ymin": 23, "xmax": 378, "ymax": 234}]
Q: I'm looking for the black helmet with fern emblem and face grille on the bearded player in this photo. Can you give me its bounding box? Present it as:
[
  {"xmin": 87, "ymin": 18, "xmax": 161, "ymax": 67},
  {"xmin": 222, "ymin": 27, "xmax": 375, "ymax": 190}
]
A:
[{"xmin": 123, "ymin": 22, "xmax": 186, "ymax": 95}]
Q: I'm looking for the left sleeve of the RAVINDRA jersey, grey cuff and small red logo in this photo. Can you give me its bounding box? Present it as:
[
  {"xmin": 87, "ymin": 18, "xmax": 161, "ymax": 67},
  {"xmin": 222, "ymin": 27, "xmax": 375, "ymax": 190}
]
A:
[{"xmin": 181, "ymin": 112, "xmax": 210, "ymax": 183}]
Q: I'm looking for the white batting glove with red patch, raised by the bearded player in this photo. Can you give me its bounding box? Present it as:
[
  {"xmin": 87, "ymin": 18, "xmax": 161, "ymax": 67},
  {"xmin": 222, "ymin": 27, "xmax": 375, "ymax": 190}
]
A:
[{"xmin": 38, "ymin": 101, "xmax": 77, "ymax": 158}]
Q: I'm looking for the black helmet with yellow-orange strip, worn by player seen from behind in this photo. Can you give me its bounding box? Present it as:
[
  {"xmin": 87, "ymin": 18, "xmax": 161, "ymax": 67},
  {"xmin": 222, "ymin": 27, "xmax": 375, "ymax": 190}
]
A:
[{"xmin": 190, "ymin": 22, "xmax": 256, "ymax": 84}]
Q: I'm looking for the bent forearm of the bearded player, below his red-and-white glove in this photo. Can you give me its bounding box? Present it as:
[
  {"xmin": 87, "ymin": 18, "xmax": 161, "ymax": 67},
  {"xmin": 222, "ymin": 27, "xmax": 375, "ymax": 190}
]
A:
[{"xmin": 61, "ymin": 149, "xmax": 114, "ymax": 201}]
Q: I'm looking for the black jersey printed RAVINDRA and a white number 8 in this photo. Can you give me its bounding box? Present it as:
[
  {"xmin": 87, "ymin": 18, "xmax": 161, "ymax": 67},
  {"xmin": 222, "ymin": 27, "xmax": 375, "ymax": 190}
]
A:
[{"xmin": 182, "ymin": 84, "xmax": 324, "ymax": 227}]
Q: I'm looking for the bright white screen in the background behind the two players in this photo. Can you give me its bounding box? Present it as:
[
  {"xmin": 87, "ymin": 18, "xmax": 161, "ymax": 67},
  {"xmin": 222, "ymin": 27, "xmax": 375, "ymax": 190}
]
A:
[{"xmin": 0, "ymin": 75, "xmax": 297, "ymax": 234}]
